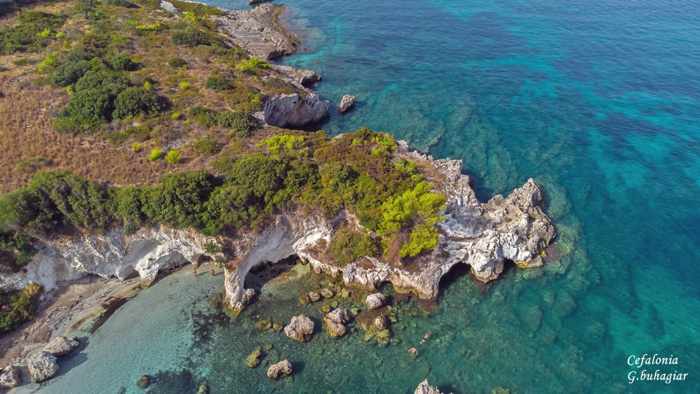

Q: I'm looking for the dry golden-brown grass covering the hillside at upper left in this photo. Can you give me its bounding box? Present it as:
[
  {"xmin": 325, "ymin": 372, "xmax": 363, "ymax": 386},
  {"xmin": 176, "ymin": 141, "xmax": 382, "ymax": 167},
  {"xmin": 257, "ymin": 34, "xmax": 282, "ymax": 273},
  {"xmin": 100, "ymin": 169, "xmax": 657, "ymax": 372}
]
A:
[{"xmin": 0, "ymin": 1, "xmax": 304, "ymax": 192}]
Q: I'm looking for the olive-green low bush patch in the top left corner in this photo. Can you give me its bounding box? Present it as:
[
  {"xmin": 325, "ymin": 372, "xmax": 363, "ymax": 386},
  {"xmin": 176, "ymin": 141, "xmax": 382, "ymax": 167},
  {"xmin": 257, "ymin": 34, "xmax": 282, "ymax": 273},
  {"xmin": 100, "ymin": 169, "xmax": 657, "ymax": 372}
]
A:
[{"xmin": 0, "ymin": 11, "xmax": 65, "ymax": 55}]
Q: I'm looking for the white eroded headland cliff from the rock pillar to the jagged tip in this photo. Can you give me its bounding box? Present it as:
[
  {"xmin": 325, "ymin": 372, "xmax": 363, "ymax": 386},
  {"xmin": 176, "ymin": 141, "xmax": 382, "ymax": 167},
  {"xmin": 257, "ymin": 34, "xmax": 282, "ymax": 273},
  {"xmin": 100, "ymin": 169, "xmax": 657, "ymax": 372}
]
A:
[{"xmin": 225, "ymin": 142, "xmax": 556, "ymax": 309}]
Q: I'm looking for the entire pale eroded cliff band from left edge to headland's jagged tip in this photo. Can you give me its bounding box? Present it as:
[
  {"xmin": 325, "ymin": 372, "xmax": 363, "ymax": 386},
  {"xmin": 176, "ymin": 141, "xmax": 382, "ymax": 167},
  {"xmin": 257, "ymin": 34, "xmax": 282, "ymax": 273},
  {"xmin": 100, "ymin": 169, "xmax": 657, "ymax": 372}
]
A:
[{"xmin": 0, "ymin": 142, "xmax": 556, "ymax": 309}]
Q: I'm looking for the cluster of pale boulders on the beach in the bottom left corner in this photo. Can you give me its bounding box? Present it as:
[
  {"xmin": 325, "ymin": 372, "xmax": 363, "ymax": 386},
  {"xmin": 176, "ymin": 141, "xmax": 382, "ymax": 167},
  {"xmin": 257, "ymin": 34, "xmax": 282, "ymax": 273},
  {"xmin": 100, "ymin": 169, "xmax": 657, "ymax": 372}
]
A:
[{"xmin": 0, "ymin": 336, "xmax": 80, "ymax": 388}]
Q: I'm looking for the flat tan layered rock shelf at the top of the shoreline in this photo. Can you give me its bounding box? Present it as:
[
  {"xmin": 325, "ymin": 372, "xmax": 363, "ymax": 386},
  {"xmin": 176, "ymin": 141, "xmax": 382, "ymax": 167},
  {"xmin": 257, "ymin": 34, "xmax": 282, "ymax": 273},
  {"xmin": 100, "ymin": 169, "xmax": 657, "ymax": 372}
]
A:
[{"xmin": 215, "ymin": 4, "xmax": 298, "ymax": 60}]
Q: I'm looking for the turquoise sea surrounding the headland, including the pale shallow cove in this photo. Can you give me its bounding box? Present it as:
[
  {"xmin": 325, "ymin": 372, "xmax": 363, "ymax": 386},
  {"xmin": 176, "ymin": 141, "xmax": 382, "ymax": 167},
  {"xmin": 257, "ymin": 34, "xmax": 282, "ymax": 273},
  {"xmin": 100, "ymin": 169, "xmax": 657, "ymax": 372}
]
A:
[{"xmin": 41, "ymin": 0, "xmax": 700, "ymax": 393}]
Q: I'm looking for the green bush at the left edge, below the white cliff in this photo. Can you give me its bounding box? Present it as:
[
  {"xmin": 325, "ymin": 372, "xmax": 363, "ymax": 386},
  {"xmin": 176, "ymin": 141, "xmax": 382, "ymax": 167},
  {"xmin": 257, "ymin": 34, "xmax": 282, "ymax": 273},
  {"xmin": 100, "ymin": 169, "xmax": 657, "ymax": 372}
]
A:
[{"xmin": 0, "ymin": 283, "xmax": 42, "ymax": 334}]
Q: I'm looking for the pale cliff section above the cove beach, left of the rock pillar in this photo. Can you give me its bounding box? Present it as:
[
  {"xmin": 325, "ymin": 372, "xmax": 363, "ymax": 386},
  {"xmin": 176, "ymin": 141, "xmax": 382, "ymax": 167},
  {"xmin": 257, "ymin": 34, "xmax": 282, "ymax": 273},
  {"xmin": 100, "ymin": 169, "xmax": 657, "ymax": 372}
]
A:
[{"xmin": 0, "ymin": 226, "xmax": 218, "ymax": 291}]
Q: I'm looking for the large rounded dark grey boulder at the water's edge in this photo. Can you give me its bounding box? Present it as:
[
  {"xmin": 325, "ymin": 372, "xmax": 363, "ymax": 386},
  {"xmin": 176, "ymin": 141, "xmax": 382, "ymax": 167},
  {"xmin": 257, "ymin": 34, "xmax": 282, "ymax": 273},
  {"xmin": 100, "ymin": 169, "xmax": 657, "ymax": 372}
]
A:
[{"xmin": 263, "ymin": 93, "xmax": 328, "ymax": 129}]
